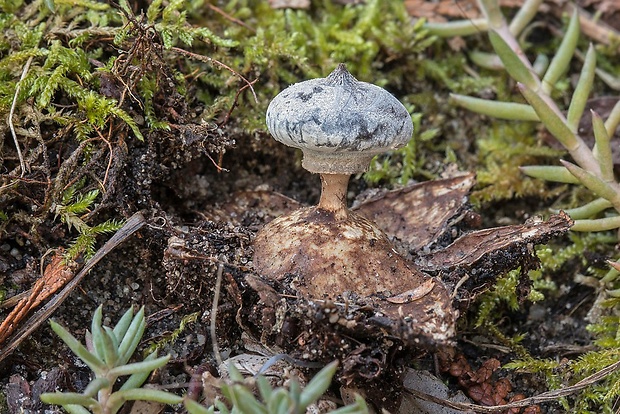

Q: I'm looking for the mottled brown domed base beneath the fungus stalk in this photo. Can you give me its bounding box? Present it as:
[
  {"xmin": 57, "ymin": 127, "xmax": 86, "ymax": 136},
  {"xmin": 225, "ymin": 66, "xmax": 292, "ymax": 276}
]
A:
[{"xmin": 254, "ymin": 207, "xmax": 457, "ymax": 345}]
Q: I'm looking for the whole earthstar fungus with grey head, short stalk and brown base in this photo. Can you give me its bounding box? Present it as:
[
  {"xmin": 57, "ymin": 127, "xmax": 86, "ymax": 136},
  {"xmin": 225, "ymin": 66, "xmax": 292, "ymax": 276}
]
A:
[{"xmin": 254, "ymin": 64, "xmax": 456, "ymax": 344}]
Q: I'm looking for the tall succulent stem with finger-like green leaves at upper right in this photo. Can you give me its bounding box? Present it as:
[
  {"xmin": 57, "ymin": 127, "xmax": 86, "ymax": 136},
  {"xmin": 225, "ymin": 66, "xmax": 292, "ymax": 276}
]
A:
[{"xmin": 430, "ymin": 0, "xmax": 620, "ymax": 239}]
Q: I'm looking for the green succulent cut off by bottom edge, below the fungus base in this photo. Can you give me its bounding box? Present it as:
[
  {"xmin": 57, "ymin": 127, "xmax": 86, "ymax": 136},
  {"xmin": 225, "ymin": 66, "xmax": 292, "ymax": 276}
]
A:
[{"xmin": 185, "ymin": 361, "xmax": 368, "ymax": 414}]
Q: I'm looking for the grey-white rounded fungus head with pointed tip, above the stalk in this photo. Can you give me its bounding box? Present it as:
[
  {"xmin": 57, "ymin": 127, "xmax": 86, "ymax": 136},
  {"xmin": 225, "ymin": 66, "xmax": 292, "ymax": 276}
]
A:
[{"xmin": 267, "ymin": 64, "xmax": 413, "ymax": 174}]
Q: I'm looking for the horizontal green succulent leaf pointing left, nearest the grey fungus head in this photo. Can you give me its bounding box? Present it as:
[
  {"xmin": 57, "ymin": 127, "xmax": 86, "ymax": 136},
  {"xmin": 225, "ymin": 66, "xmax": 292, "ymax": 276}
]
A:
[{"xmin": 450, "ymin": 94, "xmax": 540, "ymax": 121}]
